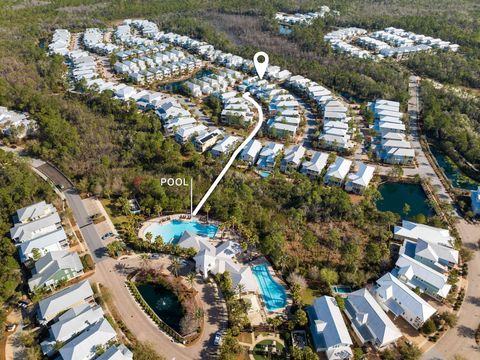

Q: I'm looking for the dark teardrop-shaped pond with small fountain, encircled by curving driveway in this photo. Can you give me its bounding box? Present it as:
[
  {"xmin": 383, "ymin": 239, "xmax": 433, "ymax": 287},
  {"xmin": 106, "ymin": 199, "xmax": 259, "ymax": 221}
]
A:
[{"xmin": 136, "ymin": 283, "xmax": 183, "ymax": 332}]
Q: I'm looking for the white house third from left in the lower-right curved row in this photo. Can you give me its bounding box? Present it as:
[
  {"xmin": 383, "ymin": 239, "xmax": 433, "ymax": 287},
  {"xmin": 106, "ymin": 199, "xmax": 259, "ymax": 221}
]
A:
[{"xmin": 373, "ymin": 273, "xmax": 437, "ymax": 329}]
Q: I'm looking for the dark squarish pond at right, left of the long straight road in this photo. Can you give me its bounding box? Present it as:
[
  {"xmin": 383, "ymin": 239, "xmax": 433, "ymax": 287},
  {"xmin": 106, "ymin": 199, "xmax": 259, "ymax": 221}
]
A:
[{"xmin": 376, "ymin": 182, "xmax": 433, "ymax": 218}]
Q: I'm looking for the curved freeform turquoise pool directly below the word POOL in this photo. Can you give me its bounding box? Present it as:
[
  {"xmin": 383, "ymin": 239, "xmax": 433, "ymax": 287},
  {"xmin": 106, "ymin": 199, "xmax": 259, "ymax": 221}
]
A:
[{"xmin": 143, "ymin": 220, "xmax": 218, "ymax": 243}]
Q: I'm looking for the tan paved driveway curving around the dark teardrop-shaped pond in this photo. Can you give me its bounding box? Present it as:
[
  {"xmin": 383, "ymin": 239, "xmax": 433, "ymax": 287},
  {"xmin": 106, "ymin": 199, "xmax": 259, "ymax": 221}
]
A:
[{"xmin": 92, "ymin": 256, "xmax": 227, "ymax": 360}]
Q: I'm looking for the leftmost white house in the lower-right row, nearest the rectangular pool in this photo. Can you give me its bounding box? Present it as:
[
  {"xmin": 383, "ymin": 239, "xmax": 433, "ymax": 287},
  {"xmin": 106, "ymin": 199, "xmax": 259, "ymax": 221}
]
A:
[{"xmin": 308, "ymin": 296, "xmax": 353, "ymax": 360}]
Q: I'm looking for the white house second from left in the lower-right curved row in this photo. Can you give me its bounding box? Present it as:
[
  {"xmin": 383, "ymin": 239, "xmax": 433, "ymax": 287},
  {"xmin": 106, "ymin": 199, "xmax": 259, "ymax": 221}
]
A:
[{"xmin": 345, "ymin": 289, "xmax": 402, "ymax": 349}]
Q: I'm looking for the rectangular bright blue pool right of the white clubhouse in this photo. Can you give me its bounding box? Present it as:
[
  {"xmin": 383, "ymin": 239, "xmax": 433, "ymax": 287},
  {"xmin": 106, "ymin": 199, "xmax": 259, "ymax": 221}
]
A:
[{"xmin": 252, "ymin": 264, "xmax": 287, "ymax": 311}]
